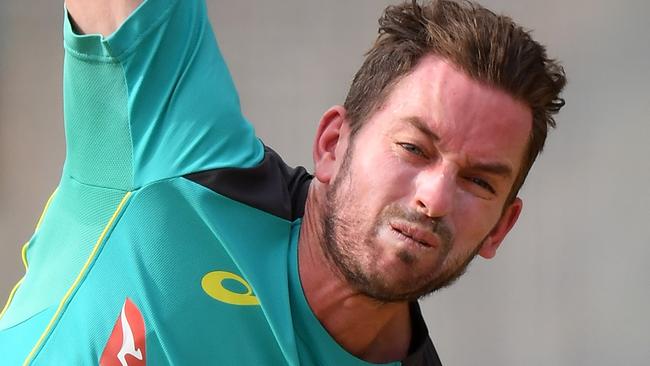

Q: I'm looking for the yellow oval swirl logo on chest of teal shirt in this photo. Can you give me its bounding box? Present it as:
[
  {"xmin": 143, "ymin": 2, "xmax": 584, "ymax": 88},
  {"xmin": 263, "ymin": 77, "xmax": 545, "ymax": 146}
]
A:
[{"xmin": 201, "ymin": 271, "xmax": 260, "ymax": 306}]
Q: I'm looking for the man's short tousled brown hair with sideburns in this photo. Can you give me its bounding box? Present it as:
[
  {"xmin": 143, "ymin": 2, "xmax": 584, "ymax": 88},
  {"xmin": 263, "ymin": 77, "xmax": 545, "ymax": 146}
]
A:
[{"xmin": 344, "ymin": 0, "xmax": 566, "ymax": 201}]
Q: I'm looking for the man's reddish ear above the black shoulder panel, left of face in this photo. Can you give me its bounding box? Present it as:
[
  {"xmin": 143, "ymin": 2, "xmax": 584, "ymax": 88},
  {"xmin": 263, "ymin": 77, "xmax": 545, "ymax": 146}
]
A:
[{"xmin": 313, "ymin": 106, "xmax": 348, "ymax": 184}]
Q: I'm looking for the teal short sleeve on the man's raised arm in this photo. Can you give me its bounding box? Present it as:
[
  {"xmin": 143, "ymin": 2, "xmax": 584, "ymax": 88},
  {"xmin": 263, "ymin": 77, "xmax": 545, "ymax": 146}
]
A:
[{"xmin": 64, "ymin": 0, "xmax": 263, "ymax": 190}]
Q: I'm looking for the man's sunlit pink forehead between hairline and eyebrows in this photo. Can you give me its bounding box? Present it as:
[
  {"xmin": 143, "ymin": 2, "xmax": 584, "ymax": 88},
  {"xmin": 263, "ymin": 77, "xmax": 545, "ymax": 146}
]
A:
[{"xmin": 371, "ymin": 56, "xmax": 532, "ymax": 169}]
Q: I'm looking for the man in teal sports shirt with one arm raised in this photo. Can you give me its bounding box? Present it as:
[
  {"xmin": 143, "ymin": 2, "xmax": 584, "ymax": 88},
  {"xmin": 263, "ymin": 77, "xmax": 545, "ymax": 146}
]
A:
[{"xmin": 0, "ymin": 0, "xmax": 565, "ymax": 365}]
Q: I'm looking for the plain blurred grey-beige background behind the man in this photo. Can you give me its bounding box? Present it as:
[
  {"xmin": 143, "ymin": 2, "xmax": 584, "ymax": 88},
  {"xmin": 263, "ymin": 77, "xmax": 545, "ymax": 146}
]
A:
[{"xmin": 0, "ymin": 0, "xmax": 650, "ymax": 366}]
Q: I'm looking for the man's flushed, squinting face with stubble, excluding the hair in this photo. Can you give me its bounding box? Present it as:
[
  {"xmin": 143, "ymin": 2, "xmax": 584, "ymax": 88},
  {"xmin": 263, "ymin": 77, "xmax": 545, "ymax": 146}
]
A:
[{"xmin": 323, "ymin": 56, "xmax": 532, "ymax": 301}]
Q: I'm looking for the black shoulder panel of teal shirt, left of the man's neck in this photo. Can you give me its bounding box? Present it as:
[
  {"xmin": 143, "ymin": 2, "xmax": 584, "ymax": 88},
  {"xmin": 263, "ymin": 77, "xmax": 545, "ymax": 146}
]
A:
[{"xmin": 185, "ymin": 146, "xmax": 313, "ymax": 221}]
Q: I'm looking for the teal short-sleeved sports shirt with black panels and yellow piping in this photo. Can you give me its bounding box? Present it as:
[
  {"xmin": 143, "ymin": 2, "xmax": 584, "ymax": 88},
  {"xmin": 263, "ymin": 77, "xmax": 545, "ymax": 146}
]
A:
[{"xmin": 0, "ymin": 0, "xmax": 439, "ymax": 366}]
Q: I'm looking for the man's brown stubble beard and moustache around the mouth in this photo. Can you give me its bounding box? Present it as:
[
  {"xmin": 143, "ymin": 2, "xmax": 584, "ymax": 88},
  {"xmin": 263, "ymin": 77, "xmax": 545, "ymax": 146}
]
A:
[{"xmin": 321, "ymin": 149, "xmax": 482, "ymax": 303}]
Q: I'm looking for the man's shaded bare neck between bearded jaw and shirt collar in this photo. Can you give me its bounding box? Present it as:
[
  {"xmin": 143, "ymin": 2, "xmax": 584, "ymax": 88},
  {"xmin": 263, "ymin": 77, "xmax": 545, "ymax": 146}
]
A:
[{"xmin": 298, "ymin": 181, "xmax": 411, "ymax": 362}]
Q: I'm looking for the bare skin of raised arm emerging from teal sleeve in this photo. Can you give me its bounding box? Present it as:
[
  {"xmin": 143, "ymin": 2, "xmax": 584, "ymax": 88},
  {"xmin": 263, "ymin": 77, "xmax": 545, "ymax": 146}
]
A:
[{"xmin": 66, "ymin": 0, "xmax": 142, "ymax": 37}]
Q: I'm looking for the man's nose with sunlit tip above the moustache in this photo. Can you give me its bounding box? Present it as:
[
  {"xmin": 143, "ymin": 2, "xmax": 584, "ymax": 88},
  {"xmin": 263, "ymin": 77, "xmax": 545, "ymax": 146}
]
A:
[{"xmin": 414, "ymin": 165, "xmax": 456, "ymax": 218}]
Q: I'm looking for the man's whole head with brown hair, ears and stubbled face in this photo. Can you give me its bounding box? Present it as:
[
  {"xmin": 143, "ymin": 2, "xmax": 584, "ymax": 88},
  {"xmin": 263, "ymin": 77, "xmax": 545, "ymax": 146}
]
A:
[{"xmin": 314, "ymin": 2, "xmax": 564, "ymax": 301}]
